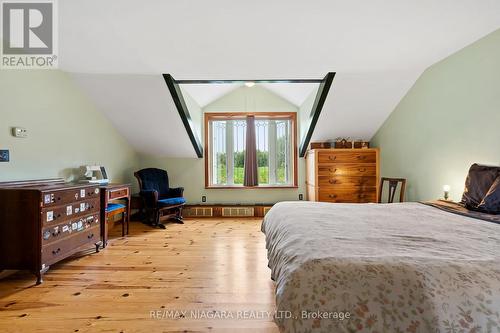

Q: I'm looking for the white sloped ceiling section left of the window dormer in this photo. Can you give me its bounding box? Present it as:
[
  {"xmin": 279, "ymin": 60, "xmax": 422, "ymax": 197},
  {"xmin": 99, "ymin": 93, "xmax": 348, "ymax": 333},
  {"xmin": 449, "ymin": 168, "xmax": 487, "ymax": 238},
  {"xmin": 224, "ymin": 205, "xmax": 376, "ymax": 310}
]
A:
[{"xmin": 73, "ymin": 74, "xmax": 196, "ymax": 157}]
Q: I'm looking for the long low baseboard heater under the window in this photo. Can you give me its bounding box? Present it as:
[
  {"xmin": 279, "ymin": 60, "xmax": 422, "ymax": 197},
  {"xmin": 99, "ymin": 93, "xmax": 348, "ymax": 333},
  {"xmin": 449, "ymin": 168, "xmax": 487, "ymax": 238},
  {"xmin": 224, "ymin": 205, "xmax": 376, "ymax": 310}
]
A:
[{"xmin": 182, "ymin": 204, "xmax": 273, "ymax": 217}]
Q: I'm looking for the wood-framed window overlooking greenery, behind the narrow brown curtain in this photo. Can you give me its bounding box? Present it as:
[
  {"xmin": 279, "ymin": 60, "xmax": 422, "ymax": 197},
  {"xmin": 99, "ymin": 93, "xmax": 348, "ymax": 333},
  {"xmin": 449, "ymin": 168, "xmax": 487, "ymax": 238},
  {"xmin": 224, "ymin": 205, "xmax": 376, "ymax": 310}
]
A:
[{"xmin": 205, "ymin": 112, "xmax": 297, "ymax": 187}]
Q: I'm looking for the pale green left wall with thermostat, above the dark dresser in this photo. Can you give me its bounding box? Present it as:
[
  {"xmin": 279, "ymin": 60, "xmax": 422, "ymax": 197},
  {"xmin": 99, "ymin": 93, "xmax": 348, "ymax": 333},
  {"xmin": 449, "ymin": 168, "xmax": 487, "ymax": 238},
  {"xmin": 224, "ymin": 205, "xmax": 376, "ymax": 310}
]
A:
[{"xmin": 0, "ymin": 70, "xmax": 137, "ymax": 184}]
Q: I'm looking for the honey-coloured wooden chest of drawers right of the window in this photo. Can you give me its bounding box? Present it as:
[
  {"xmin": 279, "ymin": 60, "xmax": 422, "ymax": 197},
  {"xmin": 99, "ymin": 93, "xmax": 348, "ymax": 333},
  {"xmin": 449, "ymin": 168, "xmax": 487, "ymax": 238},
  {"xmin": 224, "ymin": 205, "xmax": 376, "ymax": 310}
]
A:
[{"xmin": 306, "ymin": 148, "xmax": 380, "ymax": 203}]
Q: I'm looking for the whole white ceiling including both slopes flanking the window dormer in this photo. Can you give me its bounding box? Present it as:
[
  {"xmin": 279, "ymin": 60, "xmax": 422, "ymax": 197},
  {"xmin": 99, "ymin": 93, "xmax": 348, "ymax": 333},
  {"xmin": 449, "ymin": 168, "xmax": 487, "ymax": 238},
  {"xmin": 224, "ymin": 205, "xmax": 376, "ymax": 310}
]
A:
[{"xmin": 64, "ymin": 0, "xmax": 500, "ymax": 157}]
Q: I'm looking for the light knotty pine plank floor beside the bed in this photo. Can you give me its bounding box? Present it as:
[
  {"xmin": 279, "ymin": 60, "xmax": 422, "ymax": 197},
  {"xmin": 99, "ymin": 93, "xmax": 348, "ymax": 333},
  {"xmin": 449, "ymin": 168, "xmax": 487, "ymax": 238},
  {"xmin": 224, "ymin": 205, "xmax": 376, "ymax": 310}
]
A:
[{"xmin": 0, "ymin": 219, "xmax": 278, "ymax": 333}]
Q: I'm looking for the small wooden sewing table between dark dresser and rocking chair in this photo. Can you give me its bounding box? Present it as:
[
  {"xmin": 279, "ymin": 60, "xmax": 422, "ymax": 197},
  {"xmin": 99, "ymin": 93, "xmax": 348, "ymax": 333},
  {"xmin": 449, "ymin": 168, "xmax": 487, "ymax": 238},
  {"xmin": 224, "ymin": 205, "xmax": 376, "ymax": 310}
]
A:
[{"xmin": 100, "ymin": 183, "xmax": 130, "ymax": 247}]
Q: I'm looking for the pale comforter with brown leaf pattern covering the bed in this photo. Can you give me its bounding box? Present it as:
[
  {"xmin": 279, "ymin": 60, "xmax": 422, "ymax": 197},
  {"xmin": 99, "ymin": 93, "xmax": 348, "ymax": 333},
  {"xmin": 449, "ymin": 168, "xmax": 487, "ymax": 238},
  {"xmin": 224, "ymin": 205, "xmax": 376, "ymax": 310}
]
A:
[{"xmin": 262, "ymin": 202, "xmax": 500, "ymax": 333}]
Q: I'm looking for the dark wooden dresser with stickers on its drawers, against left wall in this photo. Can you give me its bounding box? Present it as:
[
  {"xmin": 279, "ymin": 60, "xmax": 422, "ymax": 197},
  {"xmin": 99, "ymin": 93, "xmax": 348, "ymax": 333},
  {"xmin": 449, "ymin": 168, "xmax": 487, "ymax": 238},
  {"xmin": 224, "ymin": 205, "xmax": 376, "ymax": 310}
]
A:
[{"xmin": 0, "ymin": 180, "xmax": 101, "ymax": 284}]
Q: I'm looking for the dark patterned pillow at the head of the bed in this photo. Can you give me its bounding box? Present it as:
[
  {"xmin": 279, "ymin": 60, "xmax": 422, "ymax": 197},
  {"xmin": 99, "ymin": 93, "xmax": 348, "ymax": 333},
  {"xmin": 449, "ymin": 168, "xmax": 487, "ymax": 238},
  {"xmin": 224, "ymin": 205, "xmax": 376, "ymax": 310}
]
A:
[{"xmin": 462, "ymin": 164, "xmax": 500, "ymax": 209}]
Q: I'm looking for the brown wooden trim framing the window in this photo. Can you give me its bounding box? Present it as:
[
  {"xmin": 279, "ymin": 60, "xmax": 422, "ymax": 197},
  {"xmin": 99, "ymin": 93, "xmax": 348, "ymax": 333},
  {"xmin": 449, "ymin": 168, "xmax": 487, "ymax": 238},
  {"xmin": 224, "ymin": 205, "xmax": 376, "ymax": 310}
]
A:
[{"xmin": 203, "ymin": 112, "xmax": 298, "ymax": 190}]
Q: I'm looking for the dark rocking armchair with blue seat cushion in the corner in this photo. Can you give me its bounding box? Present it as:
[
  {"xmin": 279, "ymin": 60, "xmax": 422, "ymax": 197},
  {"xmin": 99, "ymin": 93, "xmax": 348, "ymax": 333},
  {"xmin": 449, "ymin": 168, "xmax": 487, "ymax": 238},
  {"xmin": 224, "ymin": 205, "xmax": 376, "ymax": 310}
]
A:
[{"xmin": 134, "ymin": 168, "xmax": 186, "ymax": 228}]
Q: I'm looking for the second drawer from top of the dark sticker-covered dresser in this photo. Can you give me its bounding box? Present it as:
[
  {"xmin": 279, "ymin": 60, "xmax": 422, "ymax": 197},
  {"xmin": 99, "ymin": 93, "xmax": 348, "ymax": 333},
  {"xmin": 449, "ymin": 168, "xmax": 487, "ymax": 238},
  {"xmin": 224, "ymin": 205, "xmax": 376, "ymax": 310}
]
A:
[{"xmin": 42, "ymin": 199, "xmax": 101, "ymax": 225}]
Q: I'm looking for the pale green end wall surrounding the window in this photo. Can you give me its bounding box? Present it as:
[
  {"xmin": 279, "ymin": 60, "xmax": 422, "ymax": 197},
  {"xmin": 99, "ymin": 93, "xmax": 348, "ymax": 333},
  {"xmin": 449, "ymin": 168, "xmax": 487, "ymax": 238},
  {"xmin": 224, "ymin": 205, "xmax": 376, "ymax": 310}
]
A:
[{"xmin": 139, "ymin": 86, "xmax": 305, "ymax": 203}]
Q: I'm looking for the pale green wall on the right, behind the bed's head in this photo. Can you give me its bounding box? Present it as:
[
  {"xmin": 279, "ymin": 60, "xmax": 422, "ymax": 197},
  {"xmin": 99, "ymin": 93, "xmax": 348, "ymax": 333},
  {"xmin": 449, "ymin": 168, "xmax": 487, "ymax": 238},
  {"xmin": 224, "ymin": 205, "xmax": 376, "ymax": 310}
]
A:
[{"xmin": 372, "ymin": 30, "xmax": 500, "ymax": 201}]
